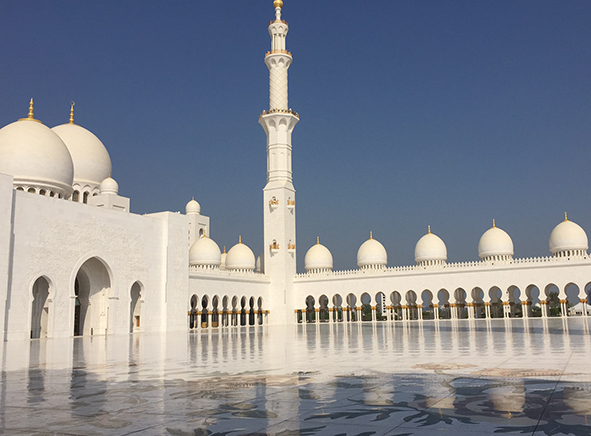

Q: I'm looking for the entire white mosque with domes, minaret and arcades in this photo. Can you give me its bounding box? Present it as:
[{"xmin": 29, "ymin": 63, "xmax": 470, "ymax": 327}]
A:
[{"xmin": 0, "ymin": 0, "xmax": 591, "ymax": 340}]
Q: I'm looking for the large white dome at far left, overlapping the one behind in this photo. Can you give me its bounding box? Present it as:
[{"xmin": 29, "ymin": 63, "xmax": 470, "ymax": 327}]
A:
[{"xmin": 0, "ymin": 111, "xmax": 75, "ymax": 197}]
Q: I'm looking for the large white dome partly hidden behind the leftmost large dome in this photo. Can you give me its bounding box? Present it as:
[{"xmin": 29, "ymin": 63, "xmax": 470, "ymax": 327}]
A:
[{"xmin": 51, "ymin": 123, "xmax": 112, "ymax": 188}]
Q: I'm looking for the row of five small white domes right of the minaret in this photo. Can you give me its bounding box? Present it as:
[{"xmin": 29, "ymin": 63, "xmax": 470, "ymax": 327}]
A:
[{"xmin": 304, "ymin": 213, "xmax": 589, "ymax": 273}]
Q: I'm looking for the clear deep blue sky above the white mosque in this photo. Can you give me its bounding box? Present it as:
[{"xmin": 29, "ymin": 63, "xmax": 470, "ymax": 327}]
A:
[{"xmin": 0, "ymin": 0, "xmax": 591, "ymax": 270}]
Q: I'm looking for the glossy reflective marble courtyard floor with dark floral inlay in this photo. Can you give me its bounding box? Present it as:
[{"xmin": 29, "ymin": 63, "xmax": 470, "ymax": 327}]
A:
[{"xmin": 0, "ymin": 317, "xmax": 591, "ymax": 436}]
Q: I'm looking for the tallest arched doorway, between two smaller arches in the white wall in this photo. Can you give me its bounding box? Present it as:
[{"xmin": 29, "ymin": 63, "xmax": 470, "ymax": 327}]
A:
[{"xmin": 74, "ymin": 257, "xmax": 111, "ymax": 336}]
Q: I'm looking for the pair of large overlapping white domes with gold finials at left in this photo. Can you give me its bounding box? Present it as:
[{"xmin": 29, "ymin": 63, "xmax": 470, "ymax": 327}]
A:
[{"xmin": 0, "ymin": 99, "xmax": 112, "ymax": 198}]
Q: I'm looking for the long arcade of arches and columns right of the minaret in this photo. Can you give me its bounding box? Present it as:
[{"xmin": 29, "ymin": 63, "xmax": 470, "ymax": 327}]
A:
[{"xmin": 294, "ymin": 282, "xmax": 591, "ymax": 323}]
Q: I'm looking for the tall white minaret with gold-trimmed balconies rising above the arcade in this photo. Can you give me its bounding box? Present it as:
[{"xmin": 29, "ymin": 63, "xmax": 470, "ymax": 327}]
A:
[{"xmin": 259, "ymin": 0, "xmax": 299, "ymax": 324}]
